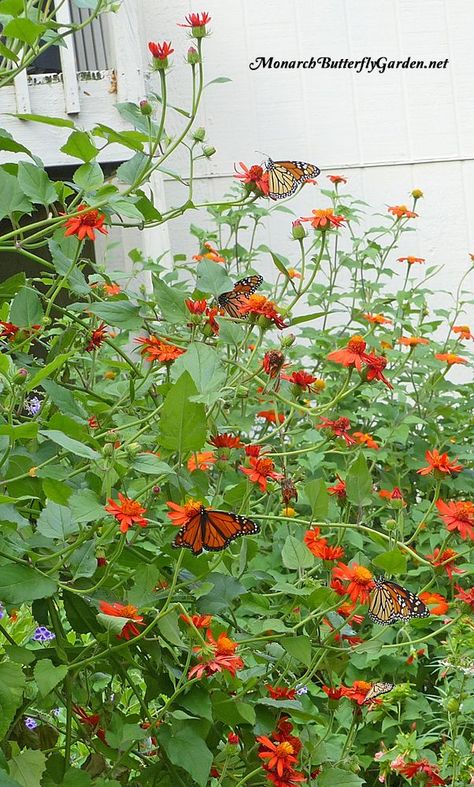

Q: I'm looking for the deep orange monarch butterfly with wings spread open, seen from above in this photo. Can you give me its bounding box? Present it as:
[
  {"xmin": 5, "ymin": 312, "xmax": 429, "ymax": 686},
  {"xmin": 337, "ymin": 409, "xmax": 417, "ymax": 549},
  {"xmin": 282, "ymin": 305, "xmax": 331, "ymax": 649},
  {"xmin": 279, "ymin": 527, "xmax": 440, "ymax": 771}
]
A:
[{"xmin": 173, "ymin": 506, "xmax": 260, "ymax": 555}]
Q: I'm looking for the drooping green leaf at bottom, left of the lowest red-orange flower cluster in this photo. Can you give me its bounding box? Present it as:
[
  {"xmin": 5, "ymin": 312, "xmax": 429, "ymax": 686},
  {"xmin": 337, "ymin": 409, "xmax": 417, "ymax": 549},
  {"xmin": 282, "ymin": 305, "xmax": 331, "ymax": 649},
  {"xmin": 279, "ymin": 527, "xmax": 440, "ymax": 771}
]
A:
[{"xmin": 157, "ymin": 721, "xmax": 213, "ymax": 787}]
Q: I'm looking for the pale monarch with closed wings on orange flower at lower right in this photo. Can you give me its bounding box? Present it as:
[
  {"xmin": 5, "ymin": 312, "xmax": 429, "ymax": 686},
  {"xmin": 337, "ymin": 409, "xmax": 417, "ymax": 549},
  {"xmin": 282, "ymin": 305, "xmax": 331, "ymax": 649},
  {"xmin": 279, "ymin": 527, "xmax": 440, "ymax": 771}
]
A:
[{"xmin": 368, "ymin": 577, "xmax": 430, "ymax": 626}]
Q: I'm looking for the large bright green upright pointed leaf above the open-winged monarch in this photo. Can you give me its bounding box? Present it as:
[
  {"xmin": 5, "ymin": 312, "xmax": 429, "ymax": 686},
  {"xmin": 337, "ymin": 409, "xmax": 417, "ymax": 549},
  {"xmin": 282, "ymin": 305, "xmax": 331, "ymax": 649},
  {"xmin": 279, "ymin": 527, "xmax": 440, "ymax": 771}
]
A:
[{"xmin": 160, "ymin": 372, "xmax": 207, "ymax": 453}]
